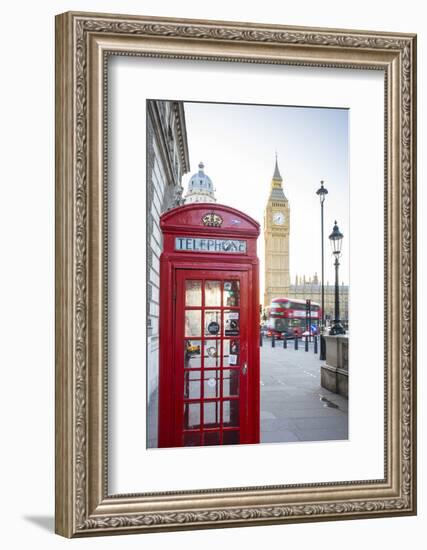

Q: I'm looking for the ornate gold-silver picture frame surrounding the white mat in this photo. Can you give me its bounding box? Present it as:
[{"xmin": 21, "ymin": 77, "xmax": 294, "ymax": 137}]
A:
[{"xmin": 55, "ymin": 13, "xmax": 416, "ymax": 537}]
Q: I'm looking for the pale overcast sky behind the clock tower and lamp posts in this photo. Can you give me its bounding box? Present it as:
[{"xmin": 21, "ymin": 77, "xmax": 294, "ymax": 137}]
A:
[{"xmin": 183, "ymin": 103, "xmax": 350, "ymax": 298}]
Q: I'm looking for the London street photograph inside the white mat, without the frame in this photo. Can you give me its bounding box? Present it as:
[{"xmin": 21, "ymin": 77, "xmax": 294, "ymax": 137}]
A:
[{"xmin": 146, "ymin": 99, "xmax": 351, "ymax": 449}]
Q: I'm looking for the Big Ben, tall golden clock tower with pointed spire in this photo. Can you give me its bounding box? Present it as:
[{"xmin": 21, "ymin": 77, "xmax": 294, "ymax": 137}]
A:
[{"xmin": 264, "ymin": 155, "xmax": 290, "ymax": 307}]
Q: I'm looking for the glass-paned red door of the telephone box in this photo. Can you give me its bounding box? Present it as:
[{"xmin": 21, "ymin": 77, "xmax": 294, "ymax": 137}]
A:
[{"xmin": 167, "ymin": 269, "xmax": 256, "ymax": 446}]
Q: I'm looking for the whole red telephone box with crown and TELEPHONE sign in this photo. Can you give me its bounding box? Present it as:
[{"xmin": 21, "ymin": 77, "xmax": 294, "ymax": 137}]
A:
[{"xmin": 158, "ymin": 203, "xmax": 260, "ymax": 447}]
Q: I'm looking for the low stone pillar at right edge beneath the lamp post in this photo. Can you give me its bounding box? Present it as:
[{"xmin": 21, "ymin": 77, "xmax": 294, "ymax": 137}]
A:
[{"xmin": 320, "ymin": 334, "xmax": 349, "ymax": 397}]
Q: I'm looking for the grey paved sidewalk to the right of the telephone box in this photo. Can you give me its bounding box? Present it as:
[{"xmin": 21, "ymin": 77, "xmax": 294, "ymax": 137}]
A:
[{"xmin": 261, "ymin": 339, "xmax": 348, "ymax": 443}]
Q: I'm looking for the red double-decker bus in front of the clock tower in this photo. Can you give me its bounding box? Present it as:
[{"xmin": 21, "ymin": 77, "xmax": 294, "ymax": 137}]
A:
[{"xmin": 267, "ymin": 298, "xmax": 322, "ymax": 339}]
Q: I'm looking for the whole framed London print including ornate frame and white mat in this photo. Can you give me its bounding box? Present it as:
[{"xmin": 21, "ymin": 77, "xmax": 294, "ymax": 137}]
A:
[{"xmin": 56, "ymin": 12, "xmax": 416, "ymax": 537}]
